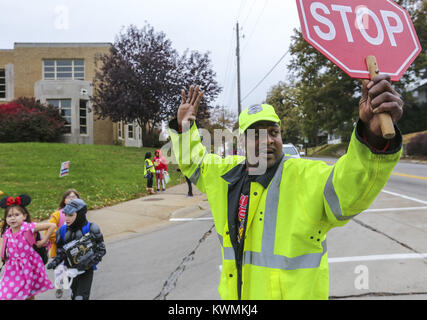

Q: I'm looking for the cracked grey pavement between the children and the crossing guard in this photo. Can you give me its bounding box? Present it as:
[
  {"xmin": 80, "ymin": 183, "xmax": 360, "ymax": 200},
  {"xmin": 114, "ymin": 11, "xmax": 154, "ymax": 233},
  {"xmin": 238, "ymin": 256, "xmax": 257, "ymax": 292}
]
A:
[{"xmin": 37, "ymin": 214, "xmax": 221, "ymax": 300}]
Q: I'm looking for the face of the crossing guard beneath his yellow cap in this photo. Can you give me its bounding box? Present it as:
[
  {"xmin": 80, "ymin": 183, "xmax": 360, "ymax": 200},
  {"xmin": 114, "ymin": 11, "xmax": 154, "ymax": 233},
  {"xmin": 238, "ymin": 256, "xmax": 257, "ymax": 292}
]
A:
[{"xmin": 246, "ymin": 121, "xmax": 283, "ymax": 168}]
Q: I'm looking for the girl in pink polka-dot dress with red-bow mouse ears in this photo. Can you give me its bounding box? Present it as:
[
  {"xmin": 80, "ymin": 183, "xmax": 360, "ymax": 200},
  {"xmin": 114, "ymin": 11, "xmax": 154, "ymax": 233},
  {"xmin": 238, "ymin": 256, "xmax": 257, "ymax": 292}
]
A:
[{"xmin": 0, "ymin": 195, "xmax": 55, "ymax": 300}]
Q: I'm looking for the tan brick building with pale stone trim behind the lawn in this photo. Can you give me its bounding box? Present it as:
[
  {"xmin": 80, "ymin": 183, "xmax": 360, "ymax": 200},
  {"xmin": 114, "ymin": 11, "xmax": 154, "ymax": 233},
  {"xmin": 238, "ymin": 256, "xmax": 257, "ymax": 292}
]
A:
[{"xmin": 0, "ymin": 43, "xmax": 142, "ymax": 147}]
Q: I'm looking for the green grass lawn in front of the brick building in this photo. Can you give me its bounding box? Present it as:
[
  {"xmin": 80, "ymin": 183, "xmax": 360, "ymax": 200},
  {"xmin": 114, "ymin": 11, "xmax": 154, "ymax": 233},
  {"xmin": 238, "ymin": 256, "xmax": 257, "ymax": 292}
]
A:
[{"xmin": 0, "ymin": 143, "xmax": 185, "ymax": 220}]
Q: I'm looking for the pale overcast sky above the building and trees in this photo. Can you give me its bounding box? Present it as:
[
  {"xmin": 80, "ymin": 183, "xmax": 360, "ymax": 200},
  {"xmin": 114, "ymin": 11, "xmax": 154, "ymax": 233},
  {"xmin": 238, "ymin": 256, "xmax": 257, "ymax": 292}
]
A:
[{"xmin": 0, "ymin": 0, "xmax": 300, "ymax": 117}]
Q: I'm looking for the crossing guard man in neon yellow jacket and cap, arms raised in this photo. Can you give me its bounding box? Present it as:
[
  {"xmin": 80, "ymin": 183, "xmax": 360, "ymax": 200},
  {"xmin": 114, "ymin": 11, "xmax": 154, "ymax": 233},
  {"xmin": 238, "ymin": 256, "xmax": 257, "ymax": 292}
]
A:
[{"xmin": 169, "ymin": 75, "xmax": 403, "ymax": 299}]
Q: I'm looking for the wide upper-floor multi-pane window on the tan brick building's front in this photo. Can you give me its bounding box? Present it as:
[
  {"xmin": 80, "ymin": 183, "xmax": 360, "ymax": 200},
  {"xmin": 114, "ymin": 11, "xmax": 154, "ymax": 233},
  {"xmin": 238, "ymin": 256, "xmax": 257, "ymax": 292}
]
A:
[{"xmin": 43, "ymin": 59, "xmax": 85, "ymax": 80}]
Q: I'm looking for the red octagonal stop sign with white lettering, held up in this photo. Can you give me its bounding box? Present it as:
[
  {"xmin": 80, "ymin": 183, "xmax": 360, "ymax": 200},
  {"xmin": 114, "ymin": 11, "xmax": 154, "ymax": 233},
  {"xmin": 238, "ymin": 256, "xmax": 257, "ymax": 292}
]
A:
[{"xmin": 297, "ymin": 0, "xmax": 421, "ymax": 81}]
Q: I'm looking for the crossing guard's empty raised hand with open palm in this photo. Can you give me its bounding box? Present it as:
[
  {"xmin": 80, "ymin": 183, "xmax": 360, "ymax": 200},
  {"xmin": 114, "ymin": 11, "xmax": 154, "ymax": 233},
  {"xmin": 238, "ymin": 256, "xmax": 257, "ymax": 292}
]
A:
[{"xmin": 178, "ymin": 85, "xmax": 203, "ymax": 128}]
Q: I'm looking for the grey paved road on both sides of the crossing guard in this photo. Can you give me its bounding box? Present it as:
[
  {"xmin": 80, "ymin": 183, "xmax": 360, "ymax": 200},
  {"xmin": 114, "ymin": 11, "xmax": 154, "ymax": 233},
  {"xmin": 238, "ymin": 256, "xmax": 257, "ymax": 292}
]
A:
[{"xmin": 37, "ymin": 159, "xmax": 427, "ymax": 300}]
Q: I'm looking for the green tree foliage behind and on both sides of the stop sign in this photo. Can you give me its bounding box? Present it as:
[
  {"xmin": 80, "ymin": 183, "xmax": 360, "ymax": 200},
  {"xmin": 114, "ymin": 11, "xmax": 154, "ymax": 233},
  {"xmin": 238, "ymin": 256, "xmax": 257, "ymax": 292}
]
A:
[{"xmin": 267, "ymin": 0, "xmax": 427, "ymax": 145}]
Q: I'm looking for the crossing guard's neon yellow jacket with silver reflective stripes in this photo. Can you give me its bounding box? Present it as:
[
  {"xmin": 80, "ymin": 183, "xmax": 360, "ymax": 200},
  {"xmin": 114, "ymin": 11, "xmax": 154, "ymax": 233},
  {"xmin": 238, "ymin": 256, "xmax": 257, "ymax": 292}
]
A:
[{"xmin": 169, "ymin": 120, "xmax": 401, "ymax": 299}]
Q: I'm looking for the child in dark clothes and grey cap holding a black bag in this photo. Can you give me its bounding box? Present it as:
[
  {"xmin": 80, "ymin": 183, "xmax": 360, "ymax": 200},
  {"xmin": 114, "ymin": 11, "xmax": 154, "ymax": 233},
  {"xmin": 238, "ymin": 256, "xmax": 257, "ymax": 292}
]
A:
[{"xmin": 47, "ymin": 199, "xmax": 106, "ymax": 300}]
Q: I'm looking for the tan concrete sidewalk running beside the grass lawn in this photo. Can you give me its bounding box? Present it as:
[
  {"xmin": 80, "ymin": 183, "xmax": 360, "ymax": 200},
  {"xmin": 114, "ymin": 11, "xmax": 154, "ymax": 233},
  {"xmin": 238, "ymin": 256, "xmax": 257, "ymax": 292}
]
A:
[{"xmin": 87, "ymin": 183, "xmax": 209, "ymax": 241}]
